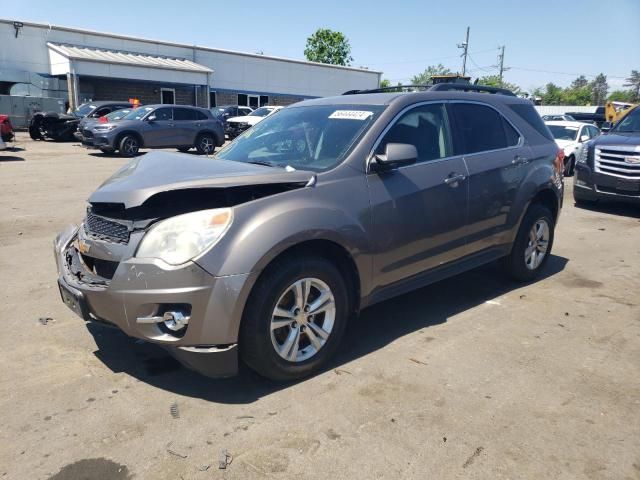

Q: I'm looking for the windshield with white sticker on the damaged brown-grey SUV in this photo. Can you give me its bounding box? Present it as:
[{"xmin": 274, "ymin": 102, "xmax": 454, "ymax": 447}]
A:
[{"xmin": 216, "ymin": 105, "xmax": 383, "ymax": 172}]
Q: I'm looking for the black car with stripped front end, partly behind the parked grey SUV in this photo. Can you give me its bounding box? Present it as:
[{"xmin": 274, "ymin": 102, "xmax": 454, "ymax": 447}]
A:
[{"xmin": 29, "ymin": 100, "xmax": 133, "ymax": 142}]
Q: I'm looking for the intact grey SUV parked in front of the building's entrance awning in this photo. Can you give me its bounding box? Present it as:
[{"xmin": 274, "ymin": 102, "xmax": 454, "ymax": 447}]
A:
[{"xmin": 81, "ymin": 105, "xmax": 224, "ymax": 157}]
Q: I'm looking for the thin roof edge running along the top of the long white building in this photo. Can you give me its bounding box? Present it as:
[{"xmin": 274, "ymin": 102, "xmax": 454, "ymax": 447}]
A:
[{"xmin": 0, "ymin": 18, "xmax": 382, "ymax": 75}]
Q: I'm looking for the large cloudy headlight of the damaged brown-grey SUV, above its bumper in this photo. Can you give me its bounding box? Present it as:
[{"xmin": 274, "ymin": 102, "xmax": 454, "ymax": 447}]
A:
[{"xmin": 136, "ymin": 208, "xmax": 233, "ymax": 265}]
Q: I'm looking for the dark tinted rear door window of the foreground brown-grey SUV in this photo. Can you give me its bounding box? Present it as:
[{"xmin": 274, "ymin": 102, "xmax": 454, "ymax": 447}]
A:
[{"xmin": 451, "ymin": 103, "xmax": 508, "ymax": 154}]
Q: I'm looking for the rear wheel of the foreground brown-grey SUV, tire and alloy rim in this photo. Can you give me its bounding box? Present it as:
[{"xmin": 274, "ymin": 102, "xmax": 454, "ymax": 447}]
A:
[{"xmin": 505, "ymin": 203, "xmax": 555, "ymax": 282}]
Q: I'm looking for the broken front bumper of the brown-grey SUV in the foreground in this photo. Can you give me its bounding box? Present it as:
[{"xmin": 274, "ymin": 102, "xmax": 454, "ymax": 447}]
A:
[{"xmin": 54, "ymin": 226, "xmax": 252, "ymax": 377}]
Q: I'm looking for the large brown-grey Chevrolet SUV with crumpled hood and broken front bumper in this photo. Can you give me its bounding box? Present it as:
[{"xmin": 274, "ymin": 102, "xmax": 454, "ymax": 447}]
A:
[{"xmin": 55, "ymin": 84, "xmax": 563, "ymax": 380}]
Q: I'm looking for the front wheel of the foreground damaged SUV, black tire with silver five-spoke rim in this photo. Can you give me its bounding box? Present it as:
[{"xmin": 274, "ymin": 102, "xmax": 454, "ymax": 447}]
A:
[{"xmin": 240, "ymin": 257, "xmax": 349, "ymax": 381}]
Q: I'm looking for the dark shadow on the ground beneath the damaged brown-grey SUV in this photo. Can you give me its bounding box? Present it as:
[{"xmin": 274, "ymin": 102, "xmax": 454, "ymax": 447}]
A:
[{"xmin": 87, "ymin": 255, "xmax": 568, "ymax": 404}]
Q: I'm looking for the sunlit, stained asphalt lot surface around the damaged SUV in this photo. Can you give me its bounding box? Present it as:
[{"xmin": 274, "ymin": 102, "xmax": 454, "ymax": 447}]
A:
[{"xmin": 0, "ymin": 133, "xmax": 640, "ymax": 480}]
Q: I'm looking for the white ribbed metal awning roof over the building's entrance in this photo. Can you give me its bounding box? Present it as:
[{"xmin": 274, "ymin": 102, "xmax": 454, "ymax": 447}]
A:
[{"xmin": 47, "ymin": 42, "xmax": 213, "ymax": 73}]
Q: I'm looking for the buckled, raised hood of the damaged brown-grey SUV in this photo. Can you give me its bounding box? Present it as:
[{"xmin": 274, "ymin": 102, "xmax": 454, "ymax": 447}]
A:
[{"xmin": 89, "ymin": 152, "xmax": 314, "ymax": 208}]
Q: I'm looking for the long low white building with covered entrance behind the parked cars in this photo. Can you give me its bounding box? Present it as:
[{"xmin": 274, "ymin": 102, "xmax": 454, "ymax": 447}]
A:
[{"xmin": 0, "ymin": 19, "xmax": 381, "ymax": 111}]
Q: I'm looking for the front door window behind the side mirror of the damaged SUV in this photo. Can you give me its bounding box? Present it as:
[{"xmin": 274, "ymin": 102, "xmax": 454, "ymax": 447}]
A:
[{"xmin": 377, "ymin": 103, "xmax": 451, "ymax": 161}]
